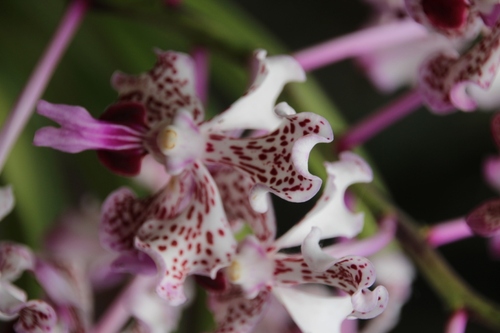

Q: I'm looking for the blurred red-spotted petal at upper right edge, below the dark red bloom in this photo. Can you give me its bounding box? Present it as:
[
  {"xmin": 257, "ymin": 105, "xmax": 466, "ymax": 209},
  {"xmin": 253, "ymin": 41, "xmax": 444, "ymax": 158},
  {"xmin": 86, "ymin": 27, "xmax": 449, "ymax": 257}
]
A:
[{"xmin": 419, "ymin": 22, "xmax": 500, "ymax": 113}]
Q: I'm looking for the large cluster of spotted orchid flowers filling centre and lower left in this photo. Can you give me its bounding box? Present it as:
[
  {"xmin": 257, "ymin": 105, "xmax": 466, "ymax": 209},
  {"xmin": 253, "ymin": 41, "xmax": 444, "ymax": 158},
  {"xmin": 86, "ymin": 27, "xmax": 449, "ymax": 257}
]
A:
[{"xmin": 0, "ymin": 47, "xmax": 394, "ymax": 333}]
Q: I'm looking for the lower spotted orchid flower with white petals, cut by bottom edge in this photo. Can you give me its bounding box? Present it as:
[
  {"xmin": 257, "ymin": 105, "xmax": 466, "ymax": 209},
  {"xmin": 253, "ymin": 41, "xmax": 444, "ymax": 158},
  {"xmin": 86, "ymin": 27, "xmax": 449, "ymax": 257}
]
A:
[{"xmin": 210, "ymin": 153, "xmax": 387, "ymax": 333}]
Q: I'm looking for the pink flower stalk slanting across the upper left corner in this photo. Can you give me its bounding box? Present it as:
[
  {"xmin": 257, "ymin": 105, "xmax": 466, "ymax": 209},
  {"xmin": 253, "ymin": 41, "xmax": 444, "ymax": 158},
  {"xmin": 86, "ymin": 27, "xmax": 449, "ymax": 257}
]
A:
[{"xmin": 0, "ymin": 0, "xmax": 89, "ymax": 170}]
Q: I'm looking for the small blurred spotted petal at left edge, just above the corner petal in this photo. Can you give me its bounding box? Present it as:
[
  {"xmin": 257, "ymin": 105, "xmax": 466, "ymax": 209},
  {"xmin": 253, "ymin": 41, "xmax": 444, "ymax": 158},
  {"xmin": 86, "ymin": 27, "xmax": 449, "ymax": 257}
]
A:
[{"xmin": 0, "ymin": 241, "xmax": 34, "ymax": 281}]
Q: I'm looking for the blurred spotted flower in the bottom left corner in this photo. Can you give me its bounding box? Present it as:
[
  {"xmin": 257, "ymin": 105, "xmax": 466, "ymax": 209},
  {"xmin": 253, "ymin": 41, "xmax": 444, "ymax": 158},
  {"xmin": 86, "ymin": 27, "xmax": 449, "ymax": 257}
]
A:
[{"xmin": 0, "ymin": 242, "xmax": 57, "ymax": 333}]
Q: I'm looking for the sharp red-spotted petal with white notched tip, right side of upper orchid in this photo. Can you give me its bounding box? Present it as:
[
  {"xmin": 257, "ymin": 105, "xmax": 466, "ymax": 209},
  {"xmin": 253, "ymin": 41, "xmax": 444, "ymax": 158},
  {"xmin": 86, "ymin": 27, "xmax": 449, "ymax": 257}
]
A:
[{"xmin": 202, "ymin": 103, "xmax": 333, "ymax": 212}]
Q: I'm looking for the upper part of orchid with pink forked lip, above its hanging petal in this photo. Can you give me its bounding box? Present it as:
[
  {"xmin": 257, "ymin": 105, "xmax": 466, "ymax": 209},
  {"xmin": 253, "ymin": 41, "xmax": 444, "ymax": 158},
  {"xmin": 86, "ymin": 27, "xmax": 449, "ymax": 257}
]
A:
[{"xmin": 35, "ymin": 51, "xmax": 333, "ymax": 211}]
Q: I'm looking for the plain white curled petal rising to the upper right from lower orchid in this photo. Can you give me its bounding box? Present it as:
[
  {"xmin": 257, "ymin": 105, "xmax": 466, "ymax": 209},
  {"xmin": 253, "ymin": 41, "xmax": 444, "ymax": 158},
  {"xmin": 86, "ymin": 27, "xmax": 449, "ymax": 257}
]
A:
[{"xmin": 276, "ymin": 152, "xmax": 373, "ymax": 248}]
